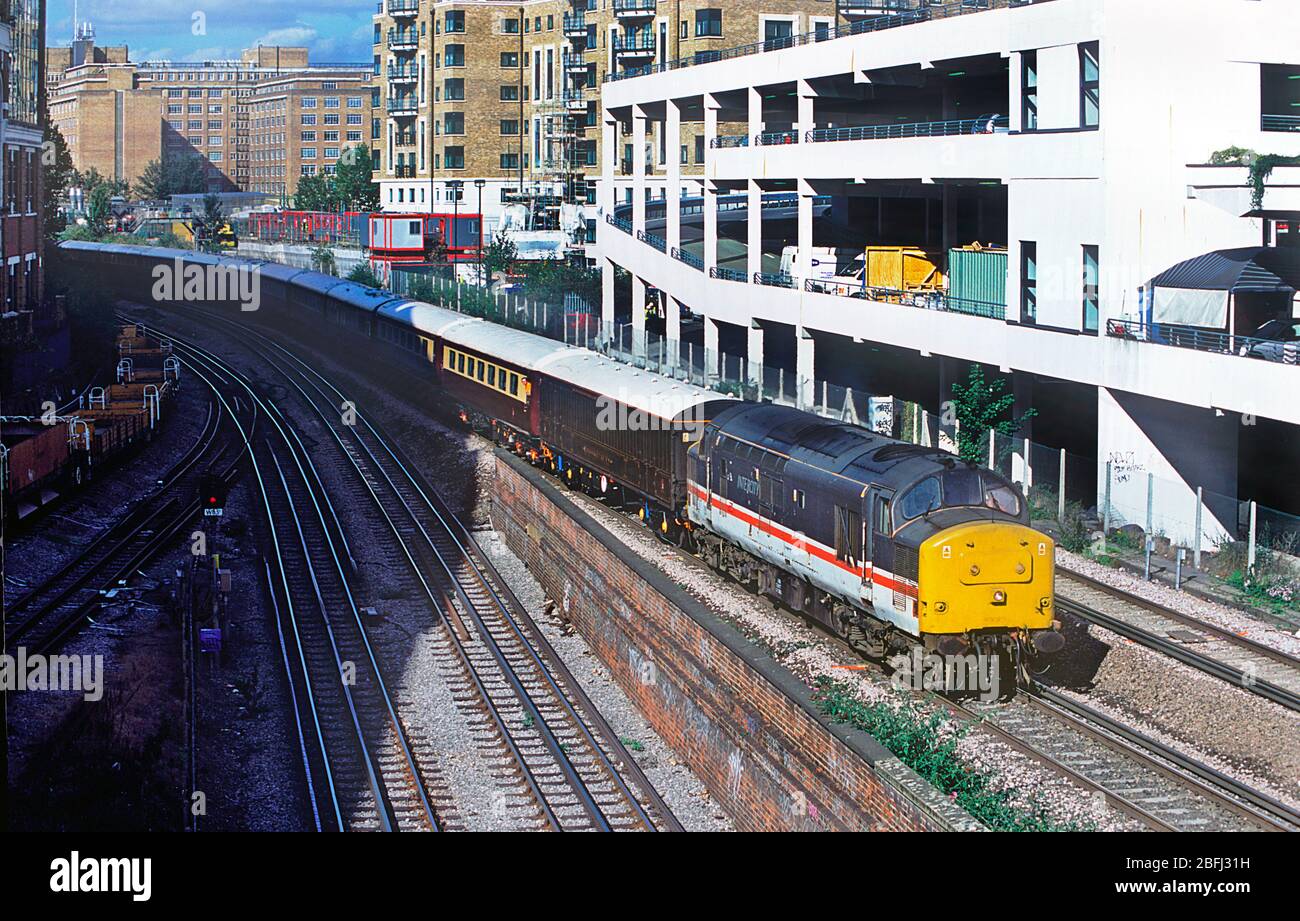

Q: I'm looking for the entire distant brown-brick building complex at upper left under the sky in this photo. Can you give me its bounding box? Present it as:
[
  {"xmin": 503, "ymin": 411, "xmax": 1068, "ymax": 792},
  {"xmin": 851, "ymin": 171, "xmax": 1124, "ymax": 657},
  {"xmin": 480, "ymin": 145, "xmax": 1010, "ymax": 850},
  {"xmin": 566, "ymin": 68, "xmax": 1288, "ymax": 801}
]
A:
[{"xmin": 48, "ymin": 40, "xmax": 371, "ymax": 199}]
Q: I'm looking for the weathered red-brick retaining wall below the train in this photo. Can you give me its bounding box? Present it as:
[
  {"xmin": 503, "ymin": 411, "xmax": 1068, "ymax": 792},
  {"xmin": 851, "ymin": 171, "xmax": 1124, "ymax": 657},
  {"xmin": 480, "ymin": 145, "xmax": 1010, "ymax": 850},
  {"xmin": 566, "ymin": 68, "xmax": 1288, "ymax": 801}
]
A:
[{"xmin": 491, "ymin": 451, "xmax": 983, "ymax": 831}]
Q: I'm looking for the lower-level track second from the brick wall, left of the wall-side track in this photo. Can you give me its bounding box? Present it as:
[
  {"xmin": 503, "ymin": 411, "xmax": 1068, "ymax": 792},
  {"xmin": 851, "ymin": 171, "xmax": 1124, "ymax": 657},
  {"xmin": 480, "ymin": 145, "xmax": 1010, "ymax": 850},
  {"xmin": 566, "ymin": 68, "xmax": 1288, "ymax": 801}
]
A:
[{"xmin": 173, "ymin": 341, "xmax": 442, "ymax": 831}]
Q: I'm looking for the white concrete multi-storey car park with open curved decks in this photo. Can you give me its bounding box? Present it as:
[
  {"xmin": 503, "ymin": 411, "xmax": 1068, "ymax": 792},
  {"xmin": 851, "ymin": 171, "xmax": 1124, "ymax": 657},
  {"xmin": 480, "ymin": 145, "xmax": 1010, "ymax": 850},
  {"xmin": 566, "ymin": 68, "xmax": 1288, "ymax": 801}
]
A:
[{"xmin": 597, "ymin": 0, "xmax": 1300, "ymax": 551}]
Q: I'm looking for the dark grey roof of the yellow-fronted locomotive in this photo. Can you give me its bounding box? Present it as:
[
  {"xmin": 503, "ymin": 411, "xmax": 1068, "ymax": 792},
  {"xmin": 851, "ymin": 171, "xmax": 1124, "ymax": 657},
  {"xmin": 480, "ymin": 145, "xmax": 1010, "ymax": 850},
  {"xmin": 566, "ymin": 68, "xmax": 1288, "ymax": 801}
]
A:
[{"xmin": 715, "ymin": 403, "xmax": 962, "ymax": 485}]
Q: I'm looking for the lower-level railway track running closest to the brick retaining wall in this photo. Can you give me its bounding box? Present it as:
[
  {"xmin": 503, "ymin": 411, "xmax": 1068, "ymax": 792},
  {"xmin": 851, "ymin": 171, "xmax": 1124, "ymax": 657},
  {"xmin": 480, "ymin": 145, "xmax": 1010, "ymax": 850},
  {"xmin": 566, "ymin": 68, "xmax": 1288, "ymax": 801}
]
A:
[{"xmin": 165, "ymin": 309, "xmax": 681, "ymax": 830}]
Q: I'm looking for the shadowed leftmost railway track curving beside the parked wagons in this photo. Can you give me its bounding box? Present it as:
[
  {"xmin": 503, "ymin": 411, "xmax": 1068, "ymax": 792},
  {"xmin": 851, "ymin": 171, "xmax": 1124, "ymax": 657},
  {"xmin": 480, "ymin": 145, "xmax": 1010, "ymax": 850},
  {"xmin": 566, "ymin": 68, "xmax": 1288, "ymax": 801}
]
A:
[{"xmin": 5, "ymin": 403, "xmax": 238, "ymax": 654}]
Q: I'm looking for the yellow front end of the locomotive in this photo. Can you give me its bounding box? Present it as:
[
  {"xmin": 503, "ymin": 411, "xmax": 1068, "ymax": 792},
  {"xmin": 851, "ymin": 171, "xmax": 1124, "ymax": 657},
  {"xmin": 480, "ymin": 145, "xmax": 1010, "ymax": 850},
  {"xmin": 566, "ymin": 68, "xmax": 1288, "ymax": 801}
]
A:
[{"xmin": 917, "ymin": 520, "xmax": 1062, "ymax": 653}]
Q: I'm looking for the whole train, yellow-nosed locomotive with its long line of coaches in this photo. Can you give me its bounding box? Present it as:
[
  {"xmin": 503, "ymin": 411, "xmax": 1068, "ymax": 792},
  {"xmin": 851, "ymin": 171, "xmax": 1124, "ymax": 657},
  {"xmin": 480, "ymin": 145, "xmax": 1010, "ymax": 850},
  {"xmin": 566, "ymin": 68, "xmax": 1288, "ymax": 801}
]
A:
[{"xmin": 61, "ymin": 243, "xmax": 1063, "ymax": 681}]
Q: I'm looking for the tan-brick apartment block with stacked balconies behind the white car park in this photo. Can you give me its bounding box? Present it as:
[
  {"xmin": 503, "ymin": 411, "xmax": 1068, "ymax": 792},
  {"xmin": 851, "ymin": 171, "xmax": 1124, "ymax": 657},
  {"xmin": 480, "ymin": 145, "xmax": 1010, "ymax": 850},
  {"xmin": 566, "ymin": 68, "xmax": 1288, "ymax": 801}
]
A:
[{"xmin": 373, "ymin": 0, "xmax": 826, "ymax": 241}]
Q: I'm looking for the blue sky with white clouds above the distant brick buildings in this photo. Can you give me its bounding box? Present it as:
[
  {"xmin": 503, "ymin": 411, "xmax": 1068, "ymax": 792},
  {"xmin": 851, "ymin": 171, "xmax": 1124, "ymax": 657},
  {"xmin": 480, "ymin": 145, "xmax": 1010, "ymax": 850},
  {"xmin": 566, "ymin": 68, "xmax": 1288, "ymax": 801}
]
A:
[{"xmin": 47, "ymin": 0, "xmax": 374, "ymax": 62}]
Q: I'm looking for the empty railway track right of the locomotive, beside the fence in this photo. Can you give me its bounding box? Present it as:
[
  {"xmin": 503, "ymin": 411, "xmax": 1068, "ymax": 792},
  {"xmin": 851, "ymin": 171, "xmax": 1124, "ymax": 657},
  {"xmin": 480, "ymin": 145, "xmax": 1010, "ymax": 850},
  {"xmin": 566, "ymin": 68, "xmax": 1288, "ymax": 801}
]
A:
[{"xmin": 1057, "ymin": 568, "xmax": 1300, "ymax": 710}]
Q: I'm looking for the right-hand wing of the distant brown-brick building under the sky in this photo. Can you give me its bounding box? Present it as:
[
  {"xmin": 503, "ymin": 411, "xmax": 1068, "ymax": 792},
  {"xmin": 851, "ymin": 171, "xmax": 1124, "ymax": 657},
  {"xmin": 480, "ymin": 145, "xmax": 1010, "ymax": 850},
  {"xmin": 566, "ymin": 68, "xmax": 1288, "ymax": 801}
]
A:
[{"xmin": 243, "ymin": 71, "xmax": 372, "ymax": 200}]
